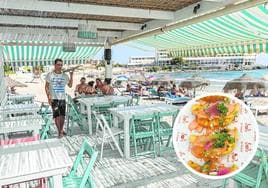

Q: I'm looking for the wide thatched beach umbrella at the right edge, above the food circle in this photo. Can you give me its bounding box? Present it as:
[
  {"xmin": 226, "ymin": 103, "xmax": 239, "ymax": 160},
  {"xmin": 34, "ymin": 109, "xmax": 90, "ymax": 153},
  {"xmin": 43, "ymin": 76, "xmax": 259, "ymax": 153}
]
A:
[{"xmin": 223, "ymin": 73, "xmax": 266, "ymax": 90}]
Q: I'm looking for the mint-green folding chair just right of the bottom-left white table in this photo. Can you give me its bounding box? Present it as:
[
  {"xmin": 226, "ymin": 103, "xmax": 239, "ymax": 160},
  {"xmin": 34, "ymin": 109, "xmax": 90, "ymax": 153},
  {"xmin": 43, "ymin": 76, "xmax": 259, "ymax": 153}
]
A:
[{"xmin": 70, "ymin": 139, "xmax": 98, "ymax": 188}]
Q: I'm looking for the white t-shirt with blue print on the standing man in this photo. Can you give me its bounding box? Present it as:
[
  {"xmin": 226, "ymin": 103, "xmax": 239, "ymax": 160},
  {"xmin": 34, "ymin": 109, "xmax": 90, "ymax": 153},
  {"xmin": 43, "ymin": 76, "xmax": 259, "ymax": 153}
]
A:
[{"xmin": 46, "ymin": 71, "xmax": 69, "ymax": 100}]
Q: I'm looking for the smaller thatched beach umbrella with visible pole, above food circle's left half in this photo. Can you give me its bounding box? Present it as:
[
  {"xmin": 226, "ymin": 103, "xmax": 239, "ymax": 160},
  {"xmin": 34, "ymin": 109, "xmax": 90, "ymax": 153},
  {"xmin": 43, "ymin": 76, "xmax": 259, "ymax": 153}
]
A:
[{"xmin": 180, "ymin": 75, "xmax": 209, "ymax": 97}]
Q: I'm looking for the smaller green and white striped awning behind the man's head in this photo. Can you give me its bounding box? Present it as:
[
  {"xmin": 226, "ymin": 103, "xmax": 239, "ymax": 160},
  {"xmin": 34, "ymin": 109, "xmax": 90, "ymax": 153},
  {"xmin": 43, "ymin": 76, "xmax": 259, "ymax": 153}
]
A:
[{"xmin": 2, "ymin": 45, "xmax": 102, "ymax": 66}]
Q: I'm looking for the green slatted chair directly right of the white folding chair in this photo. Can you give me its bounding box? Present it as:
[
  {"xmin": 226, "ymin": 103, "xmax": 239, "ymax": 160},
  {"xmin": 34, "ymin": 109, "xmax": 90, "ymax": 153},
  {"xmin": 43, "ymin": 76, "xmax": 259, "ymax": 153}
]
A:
[{"xmin": 130, "ymin": 114, "xmax": 156, "ymax": 157}]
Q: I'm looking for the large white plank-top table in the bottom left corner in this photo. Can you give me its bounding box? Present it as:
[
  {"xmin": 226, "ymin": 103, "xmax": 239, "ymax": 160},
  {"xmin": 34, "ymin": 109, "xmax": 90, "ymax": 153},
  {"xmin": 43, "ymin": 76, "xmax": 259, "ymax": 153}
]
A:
[{"xmin": 0, "ymin": 139, "xmax": 72, "ymax": 188}]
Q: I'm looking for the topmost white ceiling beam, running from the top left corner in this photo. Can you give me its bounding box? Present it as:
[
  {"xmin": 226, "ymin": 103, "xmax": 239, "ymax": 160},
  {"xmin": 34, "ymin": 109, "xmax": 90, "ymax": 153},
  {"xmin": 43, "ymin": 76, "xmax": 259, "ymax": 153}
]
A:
[{"xmin": 0, "ymin": 0, "xmax": 174, "ymax": 20}]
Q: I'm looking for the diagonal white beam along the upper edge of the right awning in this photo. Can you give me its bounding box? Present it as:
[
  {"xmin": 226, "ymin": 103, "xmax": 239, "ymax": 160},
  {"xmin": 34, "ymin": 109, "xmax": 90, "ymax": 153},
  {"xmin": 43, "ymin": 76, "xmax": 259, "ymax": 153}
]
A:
[{"xmin": 111, "ymin": 0, "xmax": 267, "ymax": 45}]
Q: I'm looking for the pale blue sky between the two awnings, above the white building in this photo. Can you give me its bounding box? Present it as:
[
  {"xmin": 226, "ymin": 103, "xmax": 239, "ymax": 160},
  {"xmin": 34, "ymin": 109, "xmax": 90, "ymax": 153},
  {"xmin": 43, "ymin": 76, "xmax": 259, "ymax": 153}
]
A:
[{"xmin": 95, "ymin": 43, "xmax": 155, "ymax": 64}]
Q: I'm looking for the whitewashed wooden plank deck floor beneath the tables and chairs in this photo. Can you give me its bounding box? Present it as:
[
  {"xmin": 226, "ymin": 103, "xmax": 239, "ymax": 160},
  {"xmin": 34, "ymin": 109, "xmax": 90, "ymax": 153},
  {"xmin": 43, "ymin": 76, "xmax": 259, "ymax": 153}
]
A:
[{"xmin": 61, "ymin": 131, "xmax": 224, "ymax": 188}]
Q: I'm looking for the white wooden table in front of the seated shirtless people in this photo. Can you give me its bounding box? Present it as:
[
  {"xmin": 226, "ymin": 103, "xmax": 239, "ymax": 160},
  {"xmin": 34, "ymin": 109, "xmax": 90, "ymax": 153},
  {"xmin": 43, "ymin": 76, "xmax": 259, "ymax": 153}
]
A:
[{"xmin": 77, "ymin": 95, "xmax": 131, "ymax": 135}]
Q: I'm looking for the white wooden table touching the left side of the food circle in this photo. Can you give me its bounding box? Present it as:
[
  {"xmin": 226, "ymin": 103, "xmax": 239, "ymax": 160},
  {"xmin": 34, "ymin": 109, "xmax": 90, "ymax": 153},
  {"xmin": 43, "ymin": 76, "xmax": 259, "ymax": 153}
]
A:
[{"xmin": 109, "ymin": 103, "xmax": 179, "ymax": 158}]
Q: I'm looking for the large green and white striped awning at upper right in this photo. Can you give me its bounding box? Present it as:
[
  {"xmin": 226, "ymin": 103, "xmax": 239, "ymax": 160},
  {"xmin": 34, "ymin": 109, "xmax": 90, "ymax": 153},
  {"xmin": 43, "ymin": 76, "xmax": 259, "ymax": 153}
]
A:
[{"xmin": 134, "ymin": 5, "xmax": 268, "ymax": 57}]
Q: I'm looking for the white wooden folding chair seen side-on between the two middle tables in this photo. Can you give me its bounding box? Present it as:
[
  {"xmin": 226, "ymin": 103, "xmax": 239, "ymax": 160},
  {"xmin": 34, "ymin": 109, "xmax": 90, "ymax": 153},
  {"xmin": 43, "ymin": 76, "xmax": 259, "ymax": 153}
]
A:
[{"xmin": 93, "ymin": 112, "xmax": 124, "ymax": 159}]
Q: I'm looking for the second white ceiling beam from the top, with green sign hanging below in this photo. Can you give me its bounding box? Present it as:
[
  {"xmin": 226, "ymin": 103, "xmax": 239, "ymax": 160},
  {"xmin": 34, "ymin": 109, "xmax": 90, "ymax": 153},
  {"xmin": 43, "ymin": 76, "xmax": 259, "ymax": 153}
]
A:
[{"xmin": 0, "ymin": 15, "xmax": 142, "ymax": 30}]
